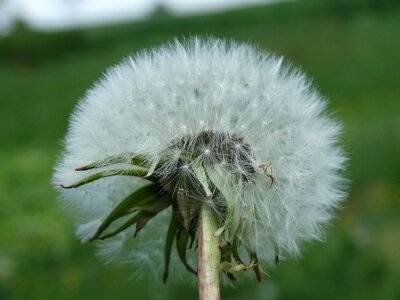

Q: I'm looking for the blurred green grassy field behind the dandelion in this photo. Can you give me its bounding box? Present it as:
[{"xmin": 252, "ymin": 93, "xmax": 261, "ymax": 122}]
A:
[{"xmin": 0, "ymin": 0, "xmax": 400, "ymax": 300}]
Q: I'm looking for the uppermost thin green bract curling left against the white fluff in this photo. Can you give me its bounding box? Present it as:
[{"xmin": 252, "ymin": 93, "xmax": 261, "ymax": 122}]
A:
[{"xmin": 75, "ymin": 153, "xmax": 147, "ymax": 171}]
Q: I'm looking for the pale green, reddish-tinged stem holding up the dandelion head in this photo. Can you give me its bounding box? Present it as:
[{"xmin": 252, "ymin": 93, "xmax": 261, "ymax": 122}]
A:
[{"xmin": 197, "ymin": 206, "xmax": 221, "ymax": 300}]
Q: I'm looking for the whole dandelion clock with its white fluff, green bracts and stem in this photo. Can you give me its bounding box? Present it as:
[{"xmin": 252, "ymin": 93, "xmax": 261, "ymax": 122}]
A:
[{"xmin": 53, "ymin": 38, "xmax": 346, "ymax": 299}]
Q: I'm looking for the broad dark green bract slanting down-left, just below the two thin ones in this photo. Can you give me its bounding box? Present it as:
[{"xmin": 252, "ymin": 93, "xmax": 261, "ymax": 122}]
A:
[{"xmin": 92, "ymin": 183, "xmax": 164, "ymax": 239}]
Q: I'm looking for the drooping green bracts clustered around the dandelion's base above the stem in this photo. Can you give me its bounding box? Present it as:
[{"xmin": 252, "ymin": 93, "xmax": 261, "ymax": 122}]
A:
[{"xmin": 63, "ymin": 132, "xmax": 261, "ymax": 282}]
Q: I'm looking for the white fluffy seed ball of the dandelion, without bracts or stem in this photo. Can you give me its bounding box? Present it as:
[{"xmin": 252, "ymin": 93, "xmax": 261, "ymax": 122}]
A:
[{"xmin": 53, "ymin": 38, "xmax": 346, "ymax": 276}]
